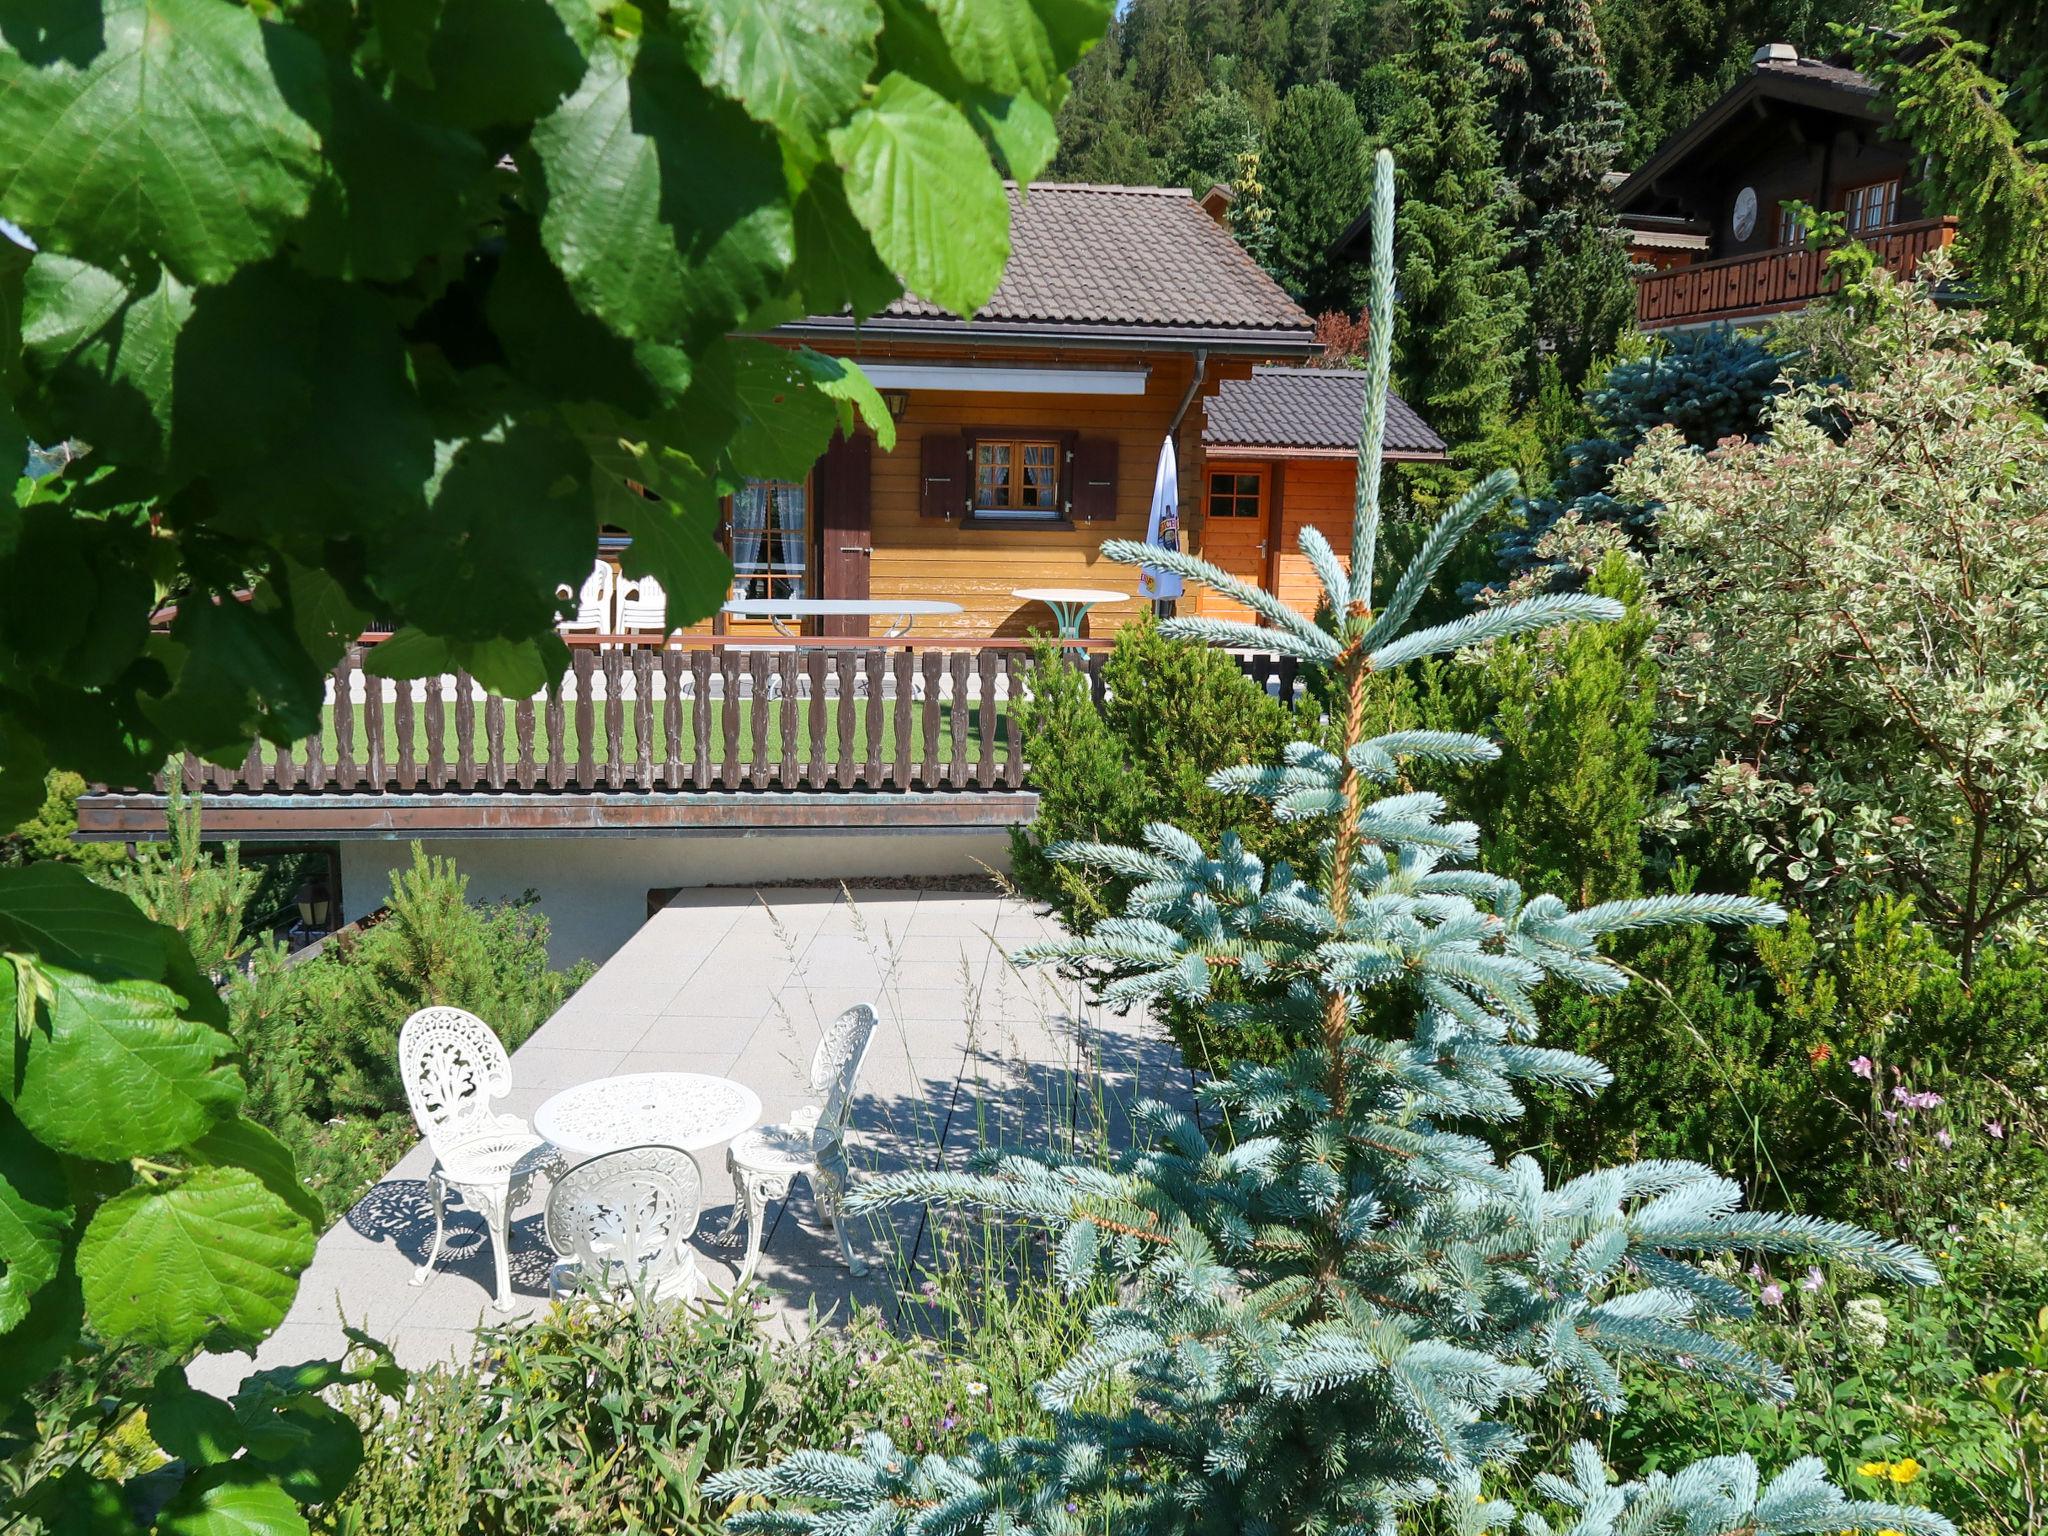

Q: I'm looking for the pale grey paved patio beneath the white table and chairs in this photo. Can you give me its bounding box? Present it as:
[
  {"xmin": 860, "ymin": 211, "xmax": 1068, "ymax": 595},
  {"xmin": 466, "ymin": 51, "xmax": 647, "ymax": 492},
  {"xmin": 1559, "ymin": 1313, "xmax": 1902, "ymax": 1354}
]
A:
[{"xmin": 190, "ymin": 889, "xmax": 1188, "ymax": 1391}]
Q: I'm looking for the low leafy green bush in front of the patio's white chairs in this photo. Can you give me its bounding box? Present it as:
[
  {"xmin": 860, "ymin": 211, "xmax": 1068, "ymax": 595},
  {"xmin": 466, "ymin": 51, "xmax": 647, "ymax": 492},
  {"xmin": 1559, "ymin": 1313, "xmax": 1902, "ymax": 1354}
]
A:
[{"xmin": 328, "ymin": 1253, "xmax": 1100, "ymax": 1536}]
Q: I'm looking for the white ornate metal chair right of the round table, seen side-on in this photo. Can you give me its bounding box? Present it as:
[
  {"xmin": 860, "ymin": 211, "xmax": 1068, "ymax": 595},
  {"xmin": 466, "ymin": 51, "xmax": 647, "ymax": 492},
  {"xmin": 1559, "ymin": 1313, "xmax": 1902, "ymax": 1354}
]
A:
[{"xmin": 721, "ymin": 1004, "xmax": 877, "ymax": 1284}]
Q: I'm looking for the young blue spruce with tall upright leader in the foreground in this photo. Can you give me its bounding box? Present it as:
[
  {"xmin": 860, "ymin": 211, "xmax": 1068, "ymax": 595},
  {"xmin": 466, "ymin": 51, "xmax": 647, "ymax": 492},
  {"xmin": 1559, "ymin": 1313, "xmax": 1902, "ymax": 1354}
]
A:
[{"xmin": 713, "ymin": 152, "xmax": 1952, "ymax": 1536}]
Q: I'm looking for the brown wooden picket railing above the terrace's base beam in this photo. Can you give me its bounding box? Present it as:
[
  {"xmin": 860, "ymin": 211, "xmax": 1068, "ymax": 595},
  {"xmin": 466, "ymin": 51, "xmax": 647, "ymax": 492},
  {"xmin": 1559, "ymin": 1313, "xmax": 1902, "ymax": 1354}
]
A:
[{"xmin": 156, "ymin": 635, "xmax": 1298, "ymax": 795}]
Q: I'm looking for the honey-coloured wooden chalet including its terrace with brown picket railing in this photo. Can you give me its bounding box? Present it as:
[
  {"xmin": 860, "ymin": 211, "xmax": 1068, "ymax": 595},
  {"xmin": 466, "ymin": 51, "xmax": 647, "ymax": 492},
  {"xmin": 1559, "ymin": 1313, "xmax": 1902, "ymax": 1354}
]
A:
[{"xmin": 80, "ymin": 184, "xmax": 1444, "ymax": 954}]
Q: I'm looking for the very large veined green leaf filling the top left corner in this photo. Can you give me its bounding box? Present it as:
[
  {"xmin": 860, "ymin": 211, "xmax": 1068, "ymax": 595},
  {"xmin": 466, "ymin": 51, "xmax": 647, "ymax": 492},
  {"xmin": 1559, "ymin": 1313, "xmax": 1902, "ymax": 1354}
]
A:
[{"xmin": 0, "ymin": 0, "xmax": 328, "ymax": 283}]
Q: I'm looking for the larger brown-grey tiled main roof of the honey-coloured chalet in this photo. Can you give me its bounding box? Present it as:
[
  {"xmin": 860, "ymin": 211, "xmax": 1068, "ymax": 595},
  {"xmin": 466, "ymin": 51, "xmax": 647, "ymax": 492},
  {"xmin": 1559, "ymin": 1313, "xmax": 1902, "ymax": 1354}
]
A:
[{"xmin": 806, "ymin": 182, "xmax": 1315, "ymax": 342}]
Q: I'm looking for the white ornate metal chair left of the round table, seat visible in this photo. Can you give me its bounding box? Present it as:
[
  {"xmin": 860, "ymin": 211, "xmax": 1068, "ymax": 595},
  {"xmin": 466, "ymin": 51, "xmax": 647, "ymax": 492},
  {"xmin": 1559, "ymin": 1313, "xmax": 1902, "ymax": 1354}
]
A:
[{"xmin": 397, "ymin": 1008, "xmax": 563, "ymax": 1311}]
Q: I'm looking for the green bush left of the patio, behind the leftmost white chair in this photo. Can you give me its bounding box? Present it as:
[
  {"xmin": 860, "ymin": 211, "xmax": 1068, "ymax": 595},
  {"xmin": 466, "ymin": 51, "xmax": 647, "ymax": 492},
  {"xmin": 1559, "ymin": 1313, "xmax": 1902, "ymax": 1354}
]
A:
[{"xmin": 227, "ymin": 844, "xmax": 578, "ymax": 1212}]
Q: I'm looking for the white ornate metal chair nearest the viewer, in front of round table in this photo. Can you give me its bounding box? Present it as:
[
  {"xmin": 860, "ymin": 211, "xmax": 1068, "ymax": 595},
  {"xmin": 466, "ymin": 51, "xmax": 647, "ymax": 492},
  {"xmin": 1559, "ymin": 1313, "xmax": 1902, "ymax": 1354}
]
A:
[{"xmin": 547, "ymin": 1145, "xmax": 705, "ymax": 1300}]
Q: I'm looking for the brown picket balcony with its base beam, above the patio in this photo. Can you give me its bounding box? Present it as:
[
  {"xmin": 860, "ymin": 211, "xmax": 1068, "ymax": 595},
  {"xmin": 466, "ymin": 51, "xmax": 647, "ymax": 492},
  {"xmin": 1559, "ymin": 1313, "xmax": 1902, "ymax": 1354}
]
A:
[{"xmin": 78, "ymin": 635, "xmax": 1298, "ymax": 842}]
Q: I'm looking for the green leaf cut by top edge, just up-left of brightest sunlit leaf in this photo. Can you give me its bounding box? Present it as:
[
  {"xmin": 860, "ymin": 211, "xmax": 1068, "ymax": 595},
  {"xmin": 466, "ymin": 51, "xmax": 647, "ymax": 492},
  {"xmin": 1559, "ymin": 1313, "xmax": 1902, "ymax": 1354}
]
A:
[{"xmin": 680, "ymin": 0, "xmax": 883, "ymax": 145}]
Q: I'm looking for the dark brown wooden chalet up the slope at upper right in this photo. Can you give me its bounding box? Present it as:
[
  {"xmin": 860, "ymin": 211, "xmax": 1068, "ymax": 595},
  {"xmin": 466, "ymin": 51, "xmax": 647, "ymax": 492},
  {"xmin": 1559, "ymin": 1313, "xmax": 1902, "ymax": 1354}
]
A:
[{"xmin": 1612, "ymin": 43, "xmax": 1956, "ymax": 332}]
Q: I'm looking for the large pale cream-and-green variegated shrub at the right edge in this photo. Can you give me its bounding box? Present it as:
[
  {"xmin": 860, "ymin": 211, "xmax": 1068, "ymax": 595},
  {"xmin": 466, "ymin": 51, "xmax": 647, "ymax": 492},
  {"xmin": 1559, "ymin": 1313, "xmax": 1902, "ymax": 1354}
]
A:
[{"xmin": 1616, "ymin": 264, "xmax": 2048, "ymax": 979}]
